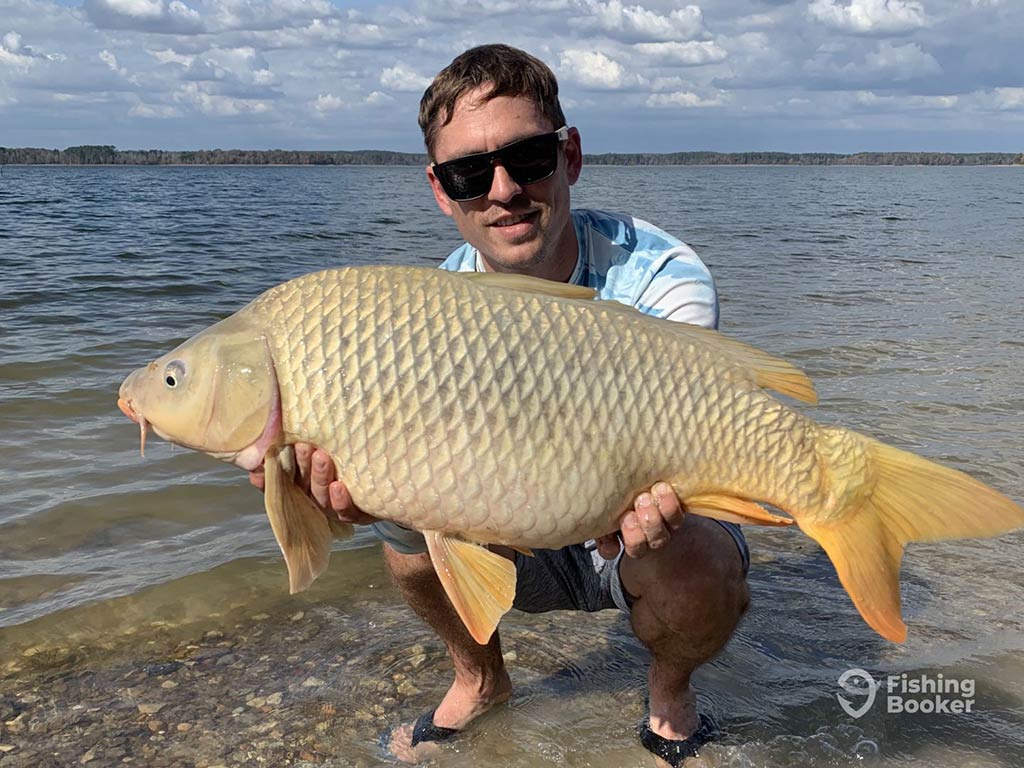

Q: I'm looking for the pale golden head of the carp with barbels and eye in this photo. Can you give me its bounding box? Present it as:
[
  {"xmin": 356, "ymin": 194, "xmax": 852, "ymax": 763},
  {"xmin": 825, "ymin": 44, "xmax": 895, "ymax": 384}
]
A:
[{"xmin": 118, "ymin": 315, "xmax": 281, "ymax": 470}]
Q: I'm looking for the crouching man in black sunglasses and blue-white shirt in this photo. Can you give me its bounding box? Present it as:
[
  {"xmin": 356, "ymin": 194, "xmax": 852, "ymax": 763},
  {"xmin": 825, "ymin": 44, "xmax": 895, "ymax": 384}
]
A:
[{"xmin": 254, "ymin": 45, "xmax": 749, "ymax": 765}]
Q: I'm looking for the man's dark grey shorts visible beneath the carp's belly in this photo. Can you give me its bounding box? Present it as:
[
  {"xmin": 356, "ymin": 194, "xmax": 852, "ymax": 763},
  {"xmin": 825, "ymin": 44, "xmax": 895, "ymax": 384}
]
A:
[{"xmin": 371, "ymin": 520, "xmax": 751, "ymax": 613}]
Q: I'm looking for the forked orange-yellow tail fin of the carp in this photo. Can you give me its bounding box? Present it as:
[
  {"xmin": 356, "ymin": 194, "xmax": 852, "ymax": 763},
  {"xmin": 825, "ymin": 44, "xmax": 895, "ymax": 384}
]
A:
[{"xmin": 799, "ymin": 429, "xmax": 1024, "ymax": 643}]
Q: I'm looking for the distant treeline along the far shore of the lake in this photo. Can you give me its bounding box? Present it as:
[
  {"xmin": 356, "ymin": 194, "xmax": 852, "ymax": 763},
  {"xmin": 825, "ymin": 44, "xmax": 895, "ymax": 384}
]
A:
[{"xmin": 0, "ymin": 144, "xmax": 1024, "ymax": 165}]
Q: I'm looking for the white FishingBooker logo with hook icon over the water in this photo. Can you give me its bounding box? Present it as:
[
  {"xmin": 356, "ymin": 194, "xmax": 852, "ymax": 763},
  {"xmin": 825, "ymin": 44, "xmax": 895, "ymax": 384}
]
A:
[{"xmin": 836, "ymin": 669, "xmax": 975, "ymax": 718}]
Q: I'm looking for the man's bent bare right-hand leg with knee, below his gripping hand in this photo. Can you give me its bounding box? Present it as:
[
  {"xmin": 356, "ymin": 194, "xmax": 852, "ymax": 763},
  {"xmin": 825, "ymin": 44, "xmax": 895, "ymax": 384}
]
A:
[{"xmin": 620, "ymin": 515, "xmax": 750, "ymax": 753}]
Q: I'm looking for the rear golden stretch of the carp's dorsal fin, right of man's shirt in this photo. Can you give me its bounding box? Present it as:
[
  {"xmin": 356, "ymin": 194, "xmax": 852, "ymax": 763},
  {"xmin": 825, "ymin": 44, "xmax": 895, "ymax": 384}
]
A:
[{"xmin": 595, "ymin": 301, "xmax": 818, "ymax": 403}]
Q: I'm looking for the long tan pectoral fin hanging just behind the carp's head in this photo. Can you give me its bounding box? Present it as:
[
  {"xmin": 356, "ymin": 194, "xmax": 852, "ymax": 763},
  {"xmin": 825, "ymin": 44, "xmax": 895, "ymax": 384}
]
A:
[{"xmin": 263, "ymin": 452, "xmax": 352, "ymax": 595}]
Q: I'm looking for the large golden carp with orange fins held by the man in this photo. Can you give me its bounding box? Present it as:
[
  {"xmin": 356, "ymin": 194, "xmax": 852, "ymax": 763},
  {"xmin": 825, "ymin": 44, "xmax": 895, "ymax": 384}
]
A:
[{"xmin": 119, "ymin": 267, "xmax": 1024, "ymax": 643}]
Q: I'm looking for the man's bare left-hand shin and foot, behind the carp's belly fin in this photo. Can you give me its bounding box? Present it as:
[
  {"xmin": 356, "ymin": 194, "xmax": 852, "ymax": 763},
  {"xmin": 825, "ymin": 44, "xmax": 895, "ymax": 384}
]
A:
[{"xmin": 383, "ymin": 544, "xmax": 512, "ymax": 761}]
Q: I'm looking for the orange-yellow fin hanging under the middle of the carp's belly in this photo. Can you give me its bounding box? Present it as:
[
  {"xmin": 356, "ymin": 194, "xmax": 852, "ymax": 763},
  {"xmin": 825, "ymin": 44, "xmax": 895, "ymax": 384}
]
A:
[{"xmin": 423, "ymin": 530, "xmax": 515, "ymax": 645}]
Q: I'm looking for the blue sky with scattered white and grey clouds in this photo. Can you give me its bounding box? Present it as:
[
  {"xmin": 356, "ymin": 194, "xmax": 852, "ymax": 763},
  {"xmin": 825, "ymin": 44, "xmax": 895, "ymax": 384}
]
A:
[{"xmin": 0, "ymin": 0, "xmax": 1024, "ymax": 153}]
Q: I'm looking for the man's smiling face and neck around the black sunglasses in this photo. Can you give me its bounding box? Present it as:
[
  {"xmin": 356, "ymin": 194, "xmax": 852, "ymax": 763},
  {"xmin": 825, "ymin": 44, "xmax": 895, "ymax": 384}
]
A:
[{"xmin": 427, "ymin": 89, "xmax": 583, "ymax": 280}]
